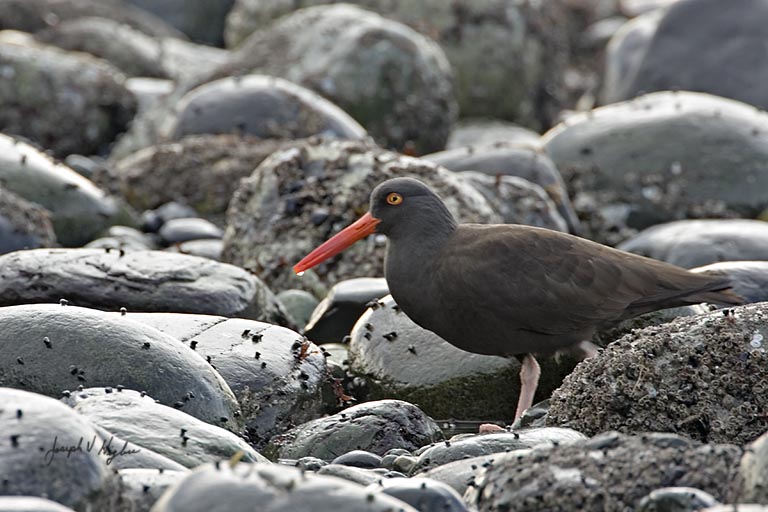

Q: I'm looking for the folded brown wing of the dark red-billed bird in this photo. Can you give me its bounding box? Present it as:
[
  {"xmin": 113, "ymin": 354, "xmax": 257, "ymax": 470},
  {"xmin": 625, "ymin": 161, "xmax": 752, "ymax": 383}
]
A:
[{"xmin": 435, "ymin": 225, "xmax": 724, "ymax": 335}]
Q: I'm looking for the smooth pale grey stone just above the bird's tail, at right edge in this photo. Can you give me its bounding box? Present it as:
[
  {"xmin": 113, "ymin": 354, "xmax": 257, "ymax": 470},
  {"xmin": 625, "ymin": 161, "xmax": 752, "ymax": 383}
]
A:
[{"xmin": 618, "ymin": 219, "xmax": 768, "ymax": 268}]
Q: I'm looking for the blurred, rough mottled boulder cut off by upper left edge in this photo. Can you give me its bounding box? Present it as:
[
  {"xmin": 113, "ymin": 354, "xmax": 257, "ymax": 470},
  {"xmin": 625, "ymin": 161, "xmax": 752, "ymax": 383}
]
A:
[{"xmin": 0, "ymin": 35, "xmax": 136, "ymax": 157}]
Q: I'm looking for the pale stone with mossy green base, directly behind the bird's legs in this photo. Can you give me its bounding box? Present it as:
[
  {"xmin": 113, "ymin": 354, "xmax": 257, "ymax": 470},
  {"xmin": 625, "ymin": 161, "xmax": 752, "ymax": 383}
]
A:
[{"xmin": 349, "ymin": 296, "xmax": 576, "ymax": 420}]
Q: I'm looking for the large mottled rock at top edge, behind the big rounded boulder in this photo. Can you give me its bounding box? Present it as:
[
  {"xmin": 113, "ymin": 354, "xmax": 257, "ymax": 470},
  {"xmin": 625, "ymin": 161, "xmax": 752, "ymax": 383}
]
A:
[{"xmin": 226, "ymin": 0, "xmax": 571, "ymax": 132}]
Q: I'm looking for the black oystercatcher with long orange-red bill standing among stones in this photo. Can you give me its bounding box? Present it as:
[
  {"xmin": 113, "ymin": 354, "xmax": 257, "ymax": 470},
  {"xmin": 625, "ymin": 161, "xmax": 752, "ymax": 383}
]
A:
[{"xmin": 293, "ymin": 178, "xmax": 742, "ymax": 418}]
